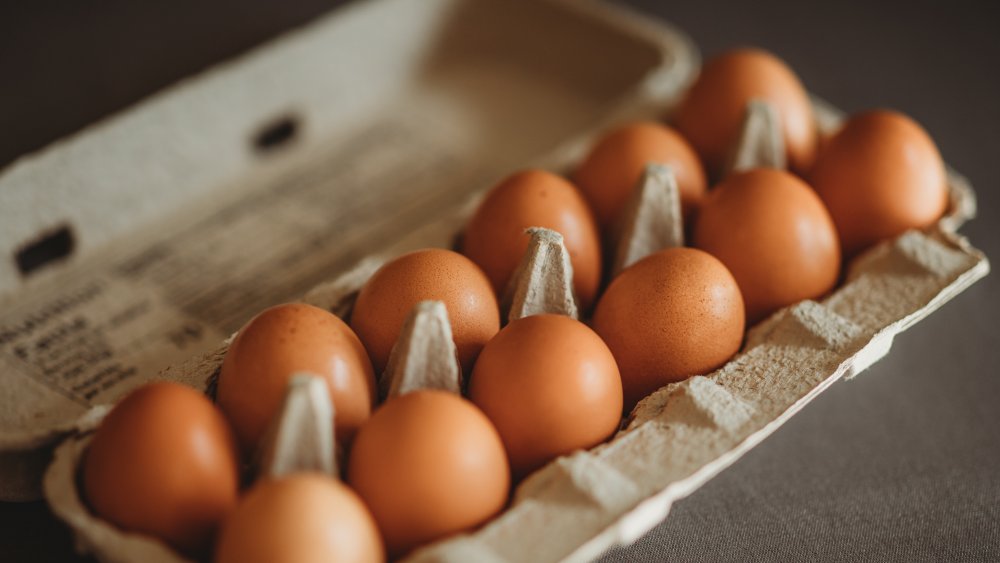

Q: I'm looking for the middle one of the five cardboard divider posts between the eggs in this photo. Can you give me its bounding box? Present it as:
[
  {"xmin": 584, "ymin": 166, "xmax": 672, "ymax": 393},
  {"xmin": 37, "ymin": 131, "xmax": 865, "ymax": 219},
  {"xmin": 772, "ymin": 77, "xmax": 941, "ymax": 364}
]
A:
[{"xmin": 502, "ymin": 227, "xmax": 580, "ymax": 322}]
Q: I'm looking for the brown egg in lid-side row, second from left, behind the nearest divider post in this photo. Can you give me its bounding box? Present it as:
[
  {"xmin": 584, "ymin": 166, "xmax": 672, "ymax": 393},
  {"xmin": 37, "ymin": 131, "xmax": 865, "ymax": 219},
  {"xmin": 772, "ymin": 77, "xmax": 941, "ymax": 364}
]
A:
[{"xmin": 216, "ymin": 303, "xmax": 375, "ymax": 453}]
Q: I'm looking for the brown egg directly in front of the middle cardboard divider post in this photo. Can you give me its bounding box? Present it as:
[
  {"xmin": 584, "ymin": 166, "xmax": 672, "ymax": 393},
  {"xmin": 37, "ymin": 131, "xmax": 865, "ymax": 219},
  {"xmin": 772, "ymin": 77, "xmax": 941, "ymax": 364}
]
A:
[{"xmin": 469, "ymin": 315, "xmax": 622, "ymax": 476}]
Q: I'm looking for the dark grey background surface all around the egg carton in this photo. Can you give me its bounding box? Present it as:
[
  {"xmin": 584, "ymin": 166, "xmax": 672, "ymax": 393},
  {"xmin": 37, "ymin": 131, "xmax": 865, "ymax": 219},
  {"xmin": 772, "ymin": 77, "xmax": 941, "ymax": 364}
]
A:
[{"xmin": 0, "ymin": 0, "xmax": 1000, "ymax": 561}]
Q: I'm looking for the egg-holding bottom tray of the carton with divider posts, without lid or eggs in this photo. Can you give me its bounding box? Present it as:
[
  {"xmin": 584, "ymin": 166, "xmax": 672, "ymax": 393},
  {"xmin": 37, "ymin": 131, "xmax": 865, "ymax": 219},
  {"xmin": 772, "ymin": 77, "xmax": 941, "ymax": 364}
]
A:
[{"xmin": 45, "ymin": 112, "xmax": 989, "ymax": 562}]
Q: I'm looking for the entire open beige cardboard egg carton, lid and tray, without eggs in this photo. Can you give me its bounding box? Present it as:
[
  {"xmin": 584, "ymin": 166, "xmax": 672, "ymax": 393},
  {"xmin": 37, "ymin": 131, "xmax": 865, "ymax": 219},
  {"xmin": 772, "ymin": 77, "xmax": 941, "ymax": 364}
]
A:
[{"xmin": 0, "ymin": 0, "xmax": 989, "ymax": 561}]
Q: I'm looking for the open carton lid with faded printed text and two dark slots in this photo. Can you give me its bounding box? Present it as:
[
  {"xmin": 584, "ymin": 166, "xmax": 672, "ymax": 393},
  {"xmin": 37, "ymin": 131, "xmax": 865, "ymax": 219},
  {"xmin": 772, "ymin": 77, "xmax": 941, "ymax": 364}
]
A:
[{"xmin": 0, "ymin": 0, "xmax": 698, "ymax": 500}]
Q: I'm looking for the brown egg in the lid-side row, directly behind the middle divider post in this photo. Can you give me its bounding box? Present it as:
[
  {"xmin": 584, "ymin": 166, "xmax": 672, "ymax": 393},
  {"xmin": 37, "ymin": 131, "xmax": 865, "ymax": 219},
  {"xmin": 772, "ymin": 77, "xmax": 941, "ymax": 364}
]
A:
[{"xmin": 462, "ymin": 170, "xmax": 601, "ymax": 309}]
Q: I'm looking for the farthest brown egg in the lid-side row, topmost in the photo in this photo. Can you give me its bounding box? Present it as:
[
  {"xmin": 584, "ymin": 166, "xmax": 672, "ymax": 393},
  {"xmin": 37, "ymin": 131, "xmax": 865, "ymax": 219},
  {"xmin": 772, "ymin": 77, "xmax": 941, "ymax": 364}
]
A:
[{"xmin": 674, "ymin": 49, "xmax": 818, "ymax": 173}]
